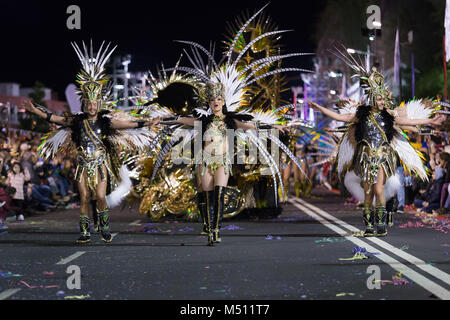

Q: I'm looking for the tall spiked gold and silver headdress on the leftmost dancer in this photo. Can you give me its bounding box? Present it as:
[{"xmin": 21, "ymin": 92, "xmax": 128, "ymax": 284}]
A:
[{"xmin": 72, "ymin": 40, "xmax": 117, "ymax": 111}]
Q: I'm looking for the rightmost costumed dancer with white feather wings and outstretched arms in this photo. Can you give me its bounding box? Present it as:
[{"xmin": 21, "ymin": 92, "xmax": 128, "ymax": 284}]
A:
[{"xmin": 308, "ymin": 58, "xmax": 445, "ymax": 236}]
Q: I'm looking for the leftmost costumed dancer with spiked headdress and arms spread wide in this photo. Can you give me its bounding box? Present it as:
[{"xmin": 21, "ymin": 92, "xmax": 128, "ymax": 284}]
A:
[{"xmin": 25, "ymin": 42, "xmax": 157, "ymax": 243}]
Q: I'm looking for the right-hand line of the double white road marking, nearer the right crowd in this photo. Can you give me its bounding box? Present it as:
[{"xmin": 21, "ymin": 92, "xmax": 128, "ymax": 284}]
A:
[{"xmin": 295, "ymin": 198, "xmax": 450, "ymax": 285}]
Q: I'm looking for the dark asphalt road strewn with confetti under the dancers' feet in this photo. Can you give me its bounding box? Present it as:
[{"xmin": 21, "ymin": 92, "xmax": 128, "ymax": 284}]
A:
[{"xmin": 0, "ymin": 189, "xmax": 450, "ymax": 300}]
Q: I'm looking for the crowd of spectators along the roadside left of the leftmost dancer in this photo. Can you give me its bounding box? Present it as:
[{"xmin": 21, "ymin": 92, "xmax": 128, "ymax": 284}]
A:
[{"xmin": 0, "ymin": 128, "xmax": 79, "ymax": 229}]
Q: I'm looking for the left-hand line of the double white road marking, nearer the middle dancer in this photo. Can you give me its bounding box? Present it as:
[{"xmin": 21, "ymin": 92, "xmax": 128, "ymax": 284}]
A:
[{"xmin": 289, "ymin": 200, "xmax": 450, "ymax": 300}]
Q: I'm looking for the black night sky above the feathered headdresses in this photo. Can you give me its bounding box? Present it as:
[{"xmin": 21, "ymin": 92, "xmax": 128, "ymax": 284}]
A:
[{"xmin": 0, "ymin": 0, "xmax": 326, "ymax": 99}]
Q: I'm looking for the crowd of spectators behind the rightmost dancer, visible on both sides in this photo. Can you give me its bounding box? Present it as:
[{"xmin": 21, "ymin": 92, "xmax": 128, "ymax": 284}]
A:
[{"xmin": 303, "ymin": 97, "xmax": 450, "ymax": 215}]
